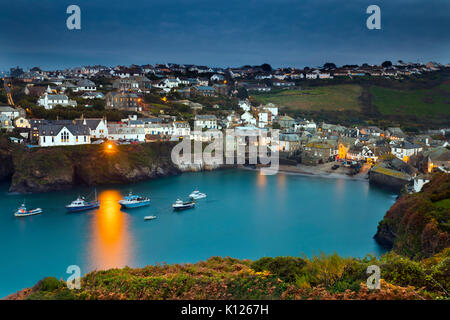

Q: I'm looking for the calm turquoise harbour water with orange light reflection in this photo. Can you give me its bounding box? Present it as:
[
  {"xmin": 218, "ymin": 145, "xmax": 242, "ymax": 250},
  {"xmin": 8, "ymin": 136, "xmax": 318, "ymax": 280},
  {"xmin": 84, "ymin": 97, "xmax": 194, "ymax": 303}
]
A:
[{"xmin": 0, "ymin": 170, "xmax": 394, "ymax": 297}]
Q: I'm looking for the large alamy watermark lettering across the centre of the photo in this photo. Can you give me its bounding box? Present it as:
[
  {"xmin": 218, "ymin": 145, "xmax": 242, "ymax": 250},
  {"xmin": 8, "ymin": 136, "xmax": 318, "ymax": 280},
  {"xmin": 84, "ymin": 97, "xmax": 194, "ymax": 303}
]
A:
[{"xmin": 171, "ymin": 129, "xmax": 279, "ymax": 175}]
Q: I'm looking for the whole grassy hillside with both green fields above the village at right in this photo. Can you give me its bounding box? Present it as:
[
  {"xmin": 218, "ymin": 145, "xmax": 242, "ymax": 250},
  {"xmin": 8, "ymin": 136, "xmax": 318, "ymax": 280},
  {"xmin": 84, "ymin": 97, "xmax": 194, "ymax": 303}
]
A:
[{"xmin": 251, "ymin": 69, "xmax": 450, "ymax": 132}]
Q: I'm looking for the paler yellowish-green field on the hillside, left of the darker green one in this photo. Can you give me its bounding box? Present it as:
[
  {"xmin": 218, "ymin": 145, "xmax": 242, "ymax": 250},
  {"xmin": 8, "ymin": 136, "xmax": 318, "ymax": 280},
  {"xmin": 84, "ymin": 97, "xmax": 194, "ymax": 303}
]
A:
[{"xmin": 251, "ymin": 84, "xmax": 362, "ymax": 111}]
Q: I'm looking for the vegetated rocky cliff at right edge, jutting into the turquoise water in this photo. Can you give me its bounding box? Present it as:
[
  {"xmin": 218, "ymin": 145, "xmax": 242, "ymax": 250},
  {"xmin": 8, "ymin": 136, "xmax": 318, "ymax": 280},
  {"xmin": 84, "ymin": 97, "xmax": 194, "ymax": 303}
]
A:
[{"xmin": 374, "ymin": 173, "xmax": 450, "ymax": 258}]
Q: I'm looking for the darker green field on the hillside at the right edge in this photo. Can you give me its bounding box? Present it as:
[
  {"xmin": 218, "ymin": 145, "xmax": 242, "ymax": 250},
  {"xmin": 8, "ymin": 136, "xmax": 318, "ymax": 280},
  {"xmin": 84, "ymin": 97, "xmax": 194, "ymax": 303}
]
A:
[{"xmin": 370, "ymin": 82, "xmax": 450, "ymax": 116}]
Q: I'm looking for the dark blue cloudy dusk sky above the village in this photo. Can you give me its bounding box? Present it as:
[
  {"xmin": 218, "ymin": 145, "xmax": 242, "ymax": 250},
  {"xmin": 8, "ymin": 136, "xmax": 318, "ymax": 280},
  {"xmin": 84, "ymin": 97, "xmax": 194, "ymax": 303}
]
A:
[{"xmin": 0, "ymin": 0, "xmax": 450, "ymax": 70}]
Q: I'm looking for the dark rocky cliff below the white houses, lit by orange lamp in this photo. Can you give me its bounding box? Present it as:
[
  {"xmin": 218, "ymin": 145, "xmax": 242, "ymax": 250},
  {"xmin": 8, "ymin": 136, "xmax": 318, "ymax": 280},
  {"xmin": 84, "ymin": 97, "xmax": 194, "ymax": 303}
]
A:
[{"xmin": 10, "ymin": 143, "xmax": 180, "ymax": 193}]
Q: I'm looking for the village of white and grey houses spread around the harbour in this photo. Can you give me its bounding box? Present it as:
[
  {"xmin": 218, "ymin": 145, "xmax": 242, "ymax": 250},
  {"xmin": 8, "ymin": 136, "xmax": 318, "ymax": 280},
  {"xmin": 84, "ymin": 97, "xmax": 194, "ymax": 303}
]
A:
[{"xmin": 0, "ymin": 61, "xmax": 450, "ymax": 191}]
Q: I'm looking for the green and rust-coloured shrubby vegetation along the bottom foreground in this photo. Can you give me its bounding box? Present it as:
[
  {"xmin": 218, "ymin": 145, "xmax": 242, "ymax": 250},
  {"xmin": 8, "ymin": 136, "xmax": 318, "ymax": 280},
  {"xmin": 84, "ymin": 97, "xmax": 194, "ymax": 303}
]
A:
[{"xmin": 9, "ymin": 249, "xmax": 450, "ymax": 300}]
